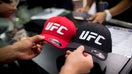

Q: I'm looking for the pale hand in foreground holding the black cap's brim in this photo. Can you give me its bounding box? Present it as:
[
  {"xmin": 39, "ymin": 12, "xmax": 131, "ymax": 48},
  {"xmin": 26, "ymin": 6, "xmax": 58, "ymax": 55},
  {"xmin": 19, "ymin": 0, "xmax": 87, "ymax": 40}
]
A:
[{"xmin": 60, "ymin": 46, "xmax": 93, "ymax": 74}]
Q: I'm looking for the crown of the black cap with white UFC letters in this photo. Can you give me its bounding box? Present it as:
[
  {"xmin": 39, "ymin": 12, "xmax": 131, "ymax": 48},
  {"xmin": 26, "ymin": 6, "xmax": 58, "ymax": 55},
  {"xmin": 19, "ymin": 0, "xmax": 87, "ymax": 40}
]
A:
[{"xmin": 73, "ymin": 23, "xmax": 112, "ymax": 52}]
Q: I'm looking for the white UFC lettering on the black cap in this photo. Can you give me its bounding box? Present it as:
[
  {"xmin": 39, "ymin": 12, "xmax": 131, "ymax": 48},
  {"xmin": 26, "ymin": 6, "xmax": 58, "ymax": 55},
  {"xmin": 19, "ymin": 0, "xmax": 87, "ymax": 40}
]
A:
[{"xmin": 79, "ymin": 31, "xmax": 105, "ymax": 45}]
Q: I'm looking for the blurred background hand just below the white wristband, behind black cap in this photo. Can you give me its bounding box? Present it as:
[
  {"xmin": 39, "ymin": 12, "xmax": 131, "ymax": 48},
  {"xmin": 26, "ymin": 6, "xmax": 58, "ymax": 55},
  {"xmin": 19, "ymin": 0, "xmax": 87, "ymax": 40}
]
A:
[{"xmin": 88, "ymin": 12, "xmax": 106, "ymax": 24}]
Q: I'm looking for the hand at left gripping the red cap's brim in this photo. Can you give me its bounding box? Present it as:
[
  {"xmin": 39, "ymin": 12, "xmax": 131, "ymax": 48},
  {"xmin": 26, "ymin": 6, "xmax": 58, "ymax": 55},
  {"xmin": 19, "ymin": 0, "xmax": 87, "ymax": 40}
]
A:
[{"xmin": 12, "ymin": 35, "xmax": 46, "ymax": 60}]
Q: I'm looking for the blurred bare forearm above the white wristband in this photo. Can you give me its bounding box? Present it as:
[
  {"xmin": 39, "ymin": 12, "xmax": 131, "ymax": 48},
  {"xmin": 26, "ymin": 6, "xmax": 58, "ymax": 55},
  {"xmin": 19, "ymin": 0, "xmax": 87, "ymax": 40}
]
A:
[{"xmin": 109, "ymin": 0, "xmax": 131, "ymax": 16}]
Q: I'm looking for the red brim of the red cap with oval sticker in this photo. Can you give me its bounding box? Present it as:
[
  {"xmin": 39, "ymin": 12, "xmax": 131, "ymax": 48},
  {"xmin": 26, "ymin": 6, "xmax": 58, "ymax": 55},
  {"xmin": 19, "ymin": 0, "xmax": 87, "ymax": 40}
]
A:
[{"xmin": 41, "ymin": 34, "xmax": 69, "ymax": 49}]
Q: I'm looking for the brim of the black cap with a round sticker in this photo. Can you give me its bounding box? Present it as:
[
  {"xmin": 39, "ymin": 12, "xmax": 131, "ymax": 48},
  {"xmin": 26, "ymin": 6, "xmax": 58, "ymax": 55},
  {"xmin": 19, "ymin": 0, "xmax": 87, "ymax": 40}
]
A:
[{"xmin": 67, "ymin": 42, "xmax": 107, "ymax": 61}]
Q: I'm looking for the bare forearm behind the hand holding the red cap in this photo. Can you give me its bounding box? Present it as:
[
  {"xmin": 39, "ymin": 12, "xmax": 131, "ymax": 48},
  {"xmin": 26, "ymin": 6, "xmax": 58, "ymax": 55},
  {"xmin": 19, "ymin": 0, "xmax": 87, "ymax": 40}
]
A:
[{"xmin": 0, "ymin": 45, "xmax": 17, "ymax": 64}]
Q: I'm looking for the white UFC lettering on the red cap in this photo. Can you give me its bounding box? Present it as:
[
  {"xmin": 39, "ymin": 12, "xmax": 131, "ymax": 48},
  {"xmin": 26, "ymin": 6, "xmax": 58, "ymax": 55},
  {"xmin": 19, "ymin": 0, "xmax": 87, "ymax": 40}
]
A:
[{"xmin": 45, "ymin": 22, "xmax": 68, "ymax": 35}]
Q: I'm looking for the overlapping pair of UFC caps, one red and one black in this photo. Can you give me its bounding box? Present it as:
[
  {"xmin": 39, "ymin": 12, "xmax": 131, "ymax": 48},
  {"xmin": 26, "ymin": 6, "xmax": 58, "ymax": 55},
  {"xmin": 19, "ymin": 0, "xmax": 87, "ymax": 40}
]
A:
[{"xmin": 41, "ymin": 16, "xmax": 112, "ymax": 60}]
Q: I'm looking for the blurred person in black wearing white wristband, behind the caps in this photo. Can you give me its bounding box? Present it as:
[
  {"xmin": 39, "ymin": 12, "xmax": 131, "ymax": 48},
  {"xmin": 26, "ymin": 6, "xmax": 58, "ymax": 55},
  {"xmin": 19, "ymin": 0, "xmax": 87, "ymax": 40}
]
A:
[{"xmin": 76, "ymin": 0, "xmax": 132, "ymax": 23}]
